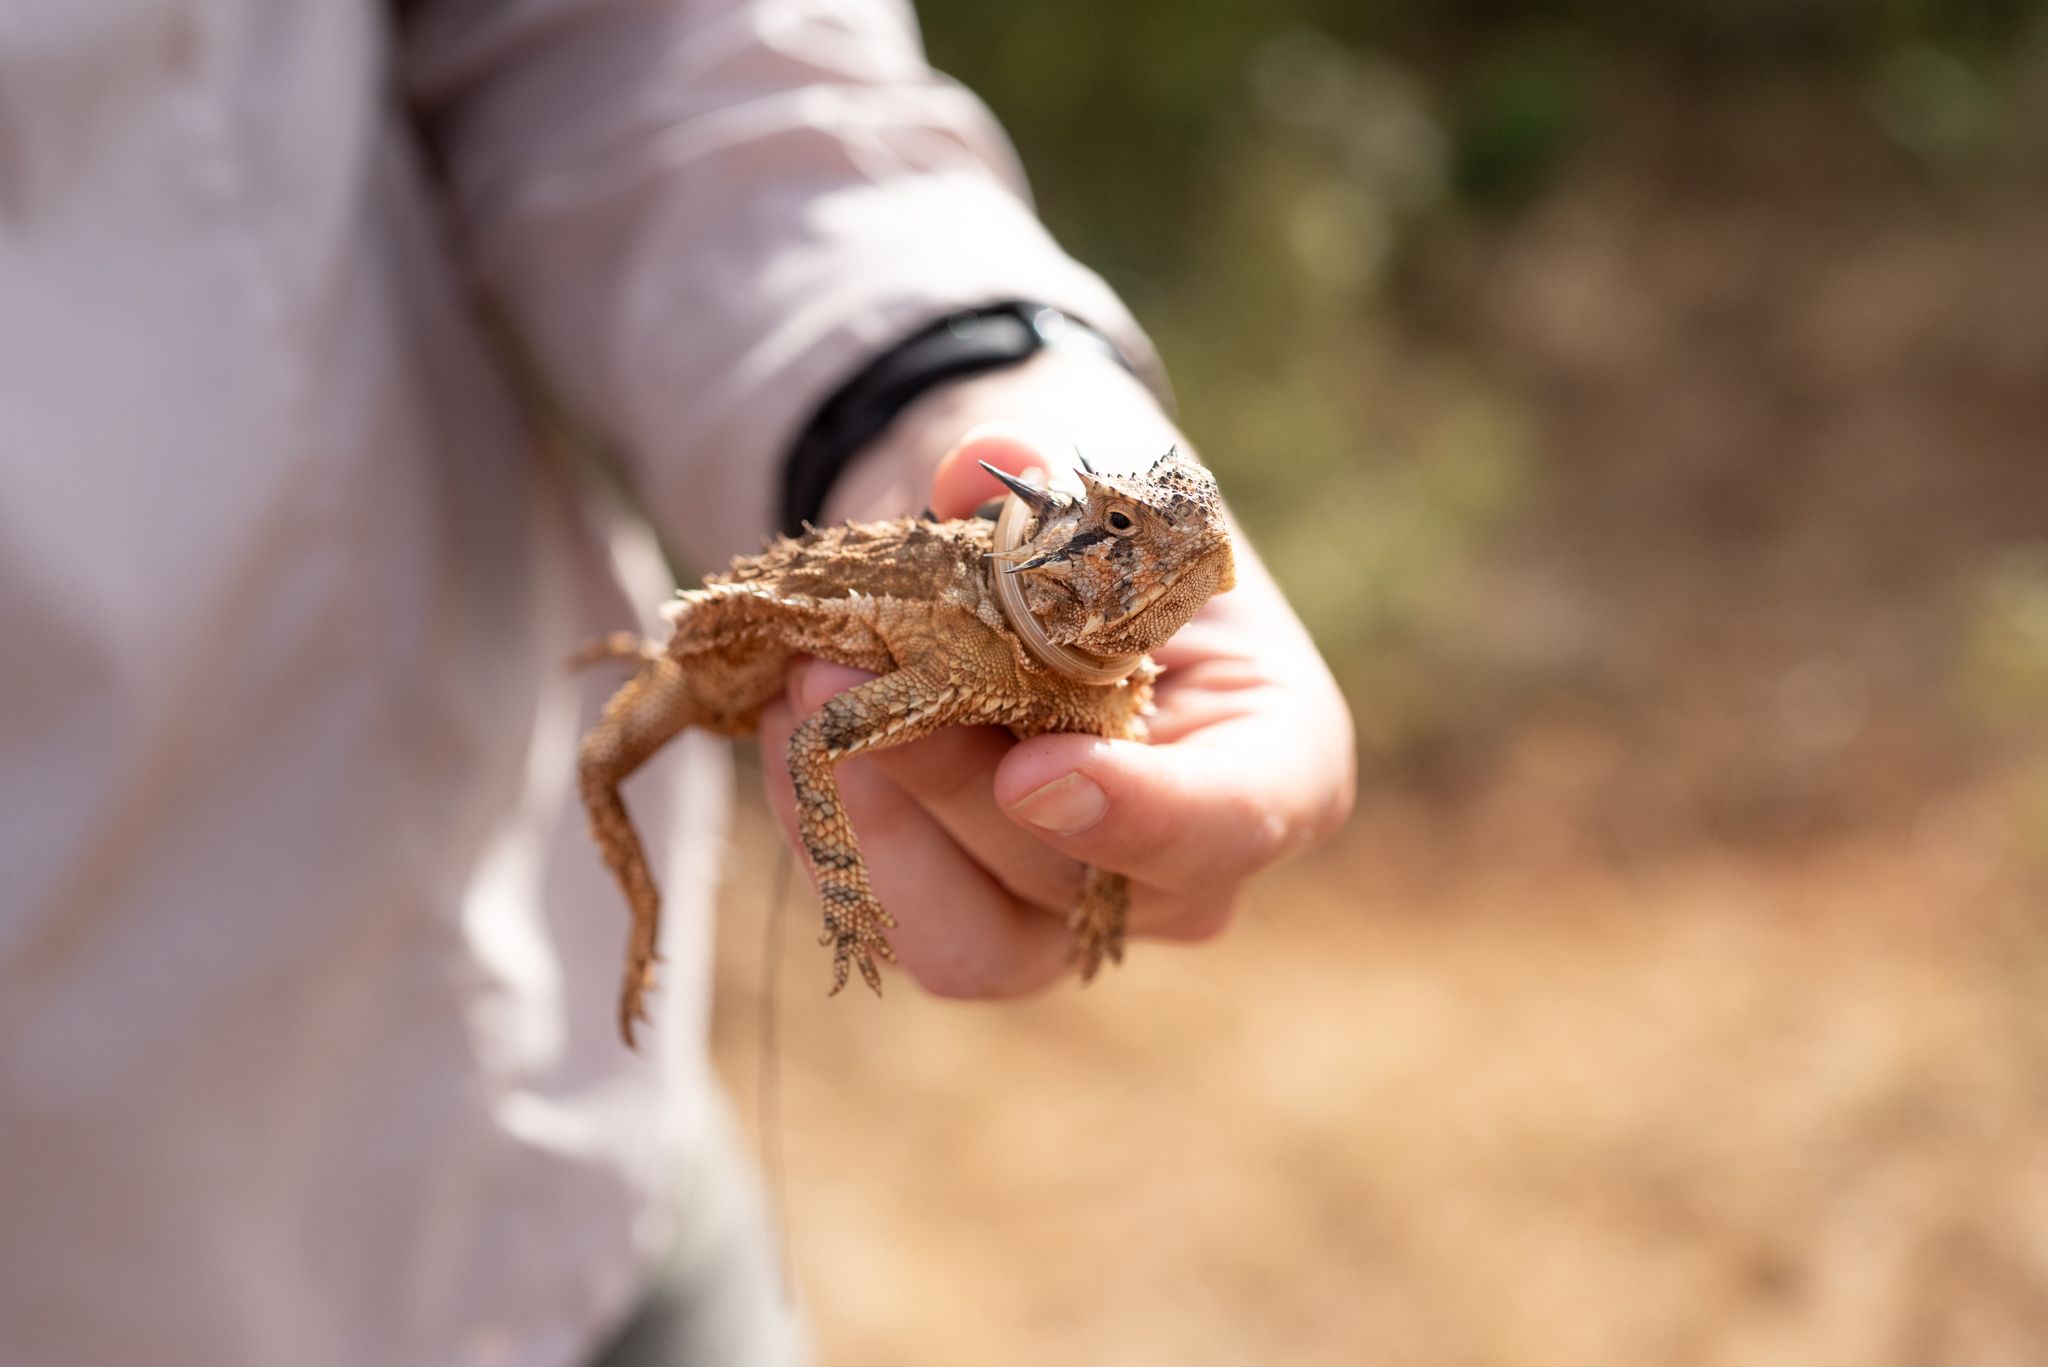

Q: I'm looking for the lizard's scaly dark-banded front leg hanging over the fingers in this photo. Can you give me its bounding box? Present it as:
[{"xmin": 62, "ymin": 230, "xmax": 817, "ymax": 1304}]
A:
[{"xmin": 788, "ymin": 670, "xmax": 969, "ymax": 994}]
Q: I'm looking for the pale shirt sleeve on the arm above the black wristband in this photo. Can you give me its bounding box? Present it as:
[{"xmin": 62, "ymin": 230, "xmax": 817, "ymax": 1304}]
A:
[{"xmin": 406, "ymin": 0, "xmax": 1157, "ymax": 564}]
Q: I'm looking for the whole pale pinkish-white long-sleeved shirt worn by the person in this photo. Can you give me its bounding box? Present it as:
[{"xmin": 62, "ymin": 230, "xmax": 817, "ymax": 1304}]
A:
[{"xmin": 0, "ymin": 0, "xmax": 1147, "ymax": 1367}]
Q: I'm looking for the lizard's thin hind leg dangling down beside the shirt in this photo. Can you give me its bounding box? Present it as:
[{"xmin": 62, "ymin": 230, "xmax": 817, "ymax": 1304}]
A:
[{"xmin": 578, "ymin": 651, "xmax": 696, "ymax": 1047}]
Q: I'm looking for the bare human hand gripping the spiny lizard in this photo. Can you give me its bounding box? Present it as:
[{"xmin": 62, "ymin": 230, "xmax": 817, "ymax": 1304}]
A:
[{"xmin": 760, "ymin": 356, "xmax": 1354, "ymax": 998}]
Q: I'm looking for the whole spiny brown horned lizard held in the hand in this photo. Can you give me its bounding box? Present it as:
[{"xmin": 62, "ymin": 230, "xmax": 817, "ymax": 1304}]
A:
[{"xmin": 573, "ymin": 451, "xmax": 1233, "ymax": 1045}]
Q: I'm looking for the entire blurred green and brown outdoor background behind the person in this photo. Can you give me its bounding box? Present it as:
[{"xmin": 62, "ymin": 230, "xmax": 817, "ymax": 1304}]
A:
[{"xmin": 717, "ymin": 0, "xmax": 2048, "ymax": 1367}]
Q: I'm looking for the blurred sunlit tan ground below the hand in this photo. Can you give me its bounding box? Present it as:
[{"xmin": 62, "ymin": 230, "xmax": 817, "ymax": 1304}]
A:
[{"xmin": 719, "ymin": 766, "xmax": 2048, "ymax": 1367}]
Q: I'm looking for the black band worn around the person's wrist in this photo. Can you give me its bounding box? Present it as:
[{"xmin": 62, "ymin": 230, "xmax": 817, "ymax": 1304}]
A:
[{"xmin": 782, "ymin": 299, "xmax": 1135, "ymax": 535}]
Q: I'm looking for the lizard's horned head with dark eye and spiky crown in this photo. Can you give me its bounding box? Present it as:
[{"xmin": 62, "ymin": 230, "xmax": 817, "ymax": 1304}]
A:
[{"xmin": 987, "ymin": 449, "xmax": 1235, "ymax": 656}]
